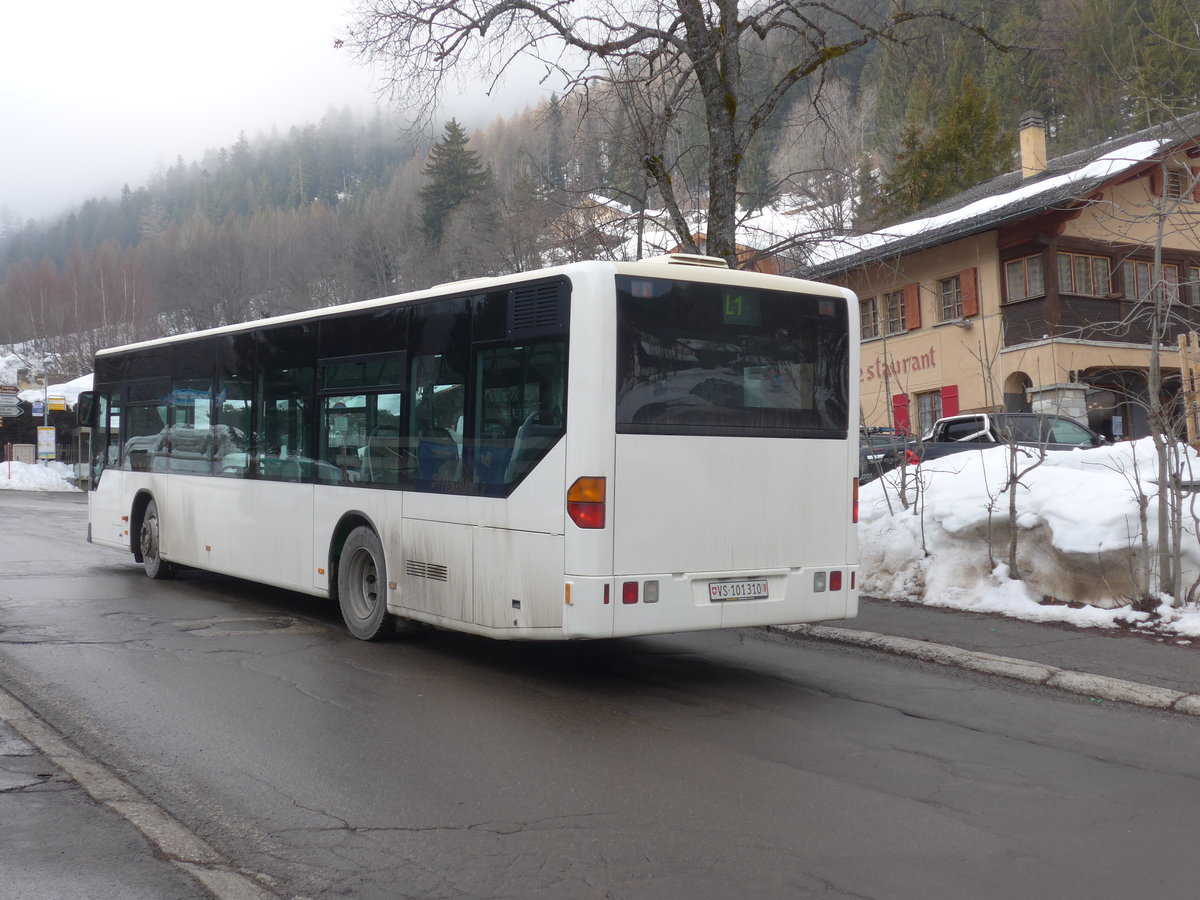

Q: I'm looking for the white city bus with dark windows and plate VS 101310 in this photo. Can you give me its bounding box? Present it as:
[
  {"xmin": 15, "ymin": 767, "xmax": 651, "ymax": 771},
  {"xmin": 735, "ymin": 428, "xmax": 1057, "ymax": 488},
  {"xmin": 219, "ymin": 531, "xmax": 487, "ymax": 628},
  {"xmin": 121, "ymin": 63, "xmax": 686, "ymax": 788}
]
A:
[{"xmin": 80, "ymin": 256, "xmax": 858, "ymax": 640}]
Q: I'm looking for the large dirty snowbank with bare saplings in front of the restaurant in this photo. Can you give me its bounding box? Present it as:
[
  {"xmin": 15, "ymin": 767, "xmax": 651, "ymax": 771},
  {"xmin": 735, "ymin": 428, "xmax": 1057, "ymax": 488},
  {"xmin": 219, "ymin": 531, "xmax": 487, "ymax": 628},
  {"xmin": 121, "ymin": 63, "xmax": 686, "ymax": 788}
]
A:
[{"xmin": 859, "ymin": 438, "xmax": 1200, "ymax": 640}]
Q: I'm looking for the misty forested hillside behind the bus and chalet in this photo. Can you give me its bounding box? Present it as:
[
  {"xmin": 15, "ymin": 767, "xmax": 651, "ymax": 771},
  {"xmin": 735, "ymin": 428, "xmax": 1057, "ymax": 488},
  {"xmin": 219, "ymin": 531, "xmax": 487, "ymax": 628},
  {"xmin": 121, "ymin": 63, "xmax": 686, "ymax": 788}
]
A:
[{"xmin": 0, "ymin": 0, "xmax": 1200, "ymax": 376}]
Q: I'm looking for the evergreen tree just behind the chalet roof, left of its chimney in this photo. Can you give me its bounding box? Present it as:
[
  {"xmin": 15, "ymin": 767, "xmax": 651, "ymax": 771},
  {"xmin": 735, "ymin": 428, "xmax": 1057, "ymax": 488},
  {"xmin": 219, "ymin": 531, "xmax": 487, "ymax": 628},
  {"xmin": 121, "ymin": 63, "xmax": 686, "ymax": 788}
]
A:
[{"xmin": 880, "ymin": 78, "xmax": 1013, "ymax": 229}]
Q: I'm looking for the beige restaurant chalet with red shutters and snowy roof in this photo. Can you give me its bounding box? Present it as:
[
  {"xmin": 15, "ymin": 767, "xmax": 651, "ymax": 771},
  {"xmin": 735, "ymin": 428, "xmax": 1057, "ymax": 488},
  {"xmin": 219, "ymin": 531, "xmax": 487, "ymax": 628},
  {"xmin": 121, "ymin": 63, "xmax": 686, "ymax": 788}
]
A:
[{"xmin": 803, "ymin": 113, "xmax": 1200, "ymax": 439}]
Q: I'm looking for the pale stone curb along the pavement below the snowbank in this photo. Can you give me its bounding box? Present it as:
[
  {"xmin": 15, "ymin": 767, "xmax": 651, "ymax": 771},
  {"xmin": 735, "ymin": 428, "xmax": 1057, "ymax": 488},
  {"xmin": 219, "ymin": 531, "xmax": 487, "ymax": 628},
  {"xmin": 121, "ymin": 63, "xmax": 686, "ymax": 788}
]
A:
[{"xmin": 773, "ymin": 625, "xmax": 1200, "ymax": 716}]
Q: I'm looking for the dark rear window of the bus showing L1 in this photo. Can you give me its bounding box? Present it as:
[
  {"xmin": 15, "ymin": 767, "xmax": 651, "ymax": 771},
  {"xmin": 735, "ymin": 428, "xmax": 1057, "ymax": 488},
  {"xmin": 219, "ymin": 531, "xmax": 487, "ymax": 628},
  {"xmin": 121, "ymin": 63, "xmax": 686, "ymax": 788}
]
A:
[{"xmin": 617, "ymin": 275, "xmax": 850, "ymax": 439}]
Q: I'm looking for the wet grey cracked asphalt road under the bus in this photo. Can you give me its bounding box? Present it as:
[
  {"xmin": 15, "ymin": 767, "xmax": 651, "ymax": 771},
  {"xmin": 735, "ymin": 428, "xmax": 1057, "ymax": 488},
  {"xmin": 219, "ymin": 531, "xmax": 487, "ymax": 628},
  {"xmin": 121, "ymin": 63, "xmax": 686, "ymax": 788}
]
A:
[{"xmin": 0, "ymin": 492, "xmax": 1200, "ymax": 900}]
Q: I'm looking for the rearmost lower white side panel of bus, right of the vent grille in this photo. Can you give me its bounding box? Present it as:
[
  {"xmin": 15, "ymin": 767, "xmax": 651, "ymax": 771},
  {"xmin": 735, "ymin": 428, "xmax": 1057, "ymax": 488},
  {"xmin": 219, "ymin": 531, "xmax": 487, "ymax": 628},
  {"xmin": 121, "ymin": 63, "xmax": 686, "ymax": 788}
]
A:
[{"xmin": 474, "ymin": 528, "xmax": 563, "ymax": 629}]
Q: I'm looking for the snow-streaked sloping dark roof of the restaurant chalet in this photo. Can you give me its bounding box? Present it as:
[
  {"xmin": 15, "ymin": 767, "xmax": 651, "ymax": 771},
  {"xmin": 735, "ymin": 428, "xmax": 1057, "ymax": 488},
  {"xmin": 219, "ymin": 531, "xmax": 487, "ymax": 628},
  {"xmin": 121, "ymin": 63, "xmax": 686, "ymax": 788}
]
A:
[{"xmin": 805, "ymin": 113, "xmax": 1200, "ymax": 277}]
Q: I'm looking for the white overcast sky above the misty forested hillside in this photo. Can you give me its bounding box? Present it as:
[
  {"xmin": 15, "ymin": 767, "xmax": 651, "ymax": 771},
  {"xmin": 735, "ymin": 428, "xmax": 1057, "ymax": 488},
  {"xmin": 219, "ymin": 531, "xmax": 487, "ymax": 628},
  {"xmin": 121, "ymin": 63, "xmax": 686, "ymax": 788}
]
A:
[{"xmin": 0, "ymin": 0, "xmax": 547, "ymax": 224}]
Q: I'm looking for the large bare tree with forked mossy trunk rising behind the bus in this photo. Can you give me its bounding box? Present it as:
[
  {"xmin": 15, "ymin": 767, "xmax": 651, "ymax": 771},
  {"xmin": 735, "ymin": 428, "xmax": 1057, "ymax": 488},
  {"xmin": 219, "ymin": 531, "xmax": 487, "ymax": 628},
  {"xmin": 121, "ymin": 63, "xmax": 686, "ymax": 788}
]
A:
[{"xmin": 338, "ymin": 0, "xmax": 994, "ymax": 264}]
